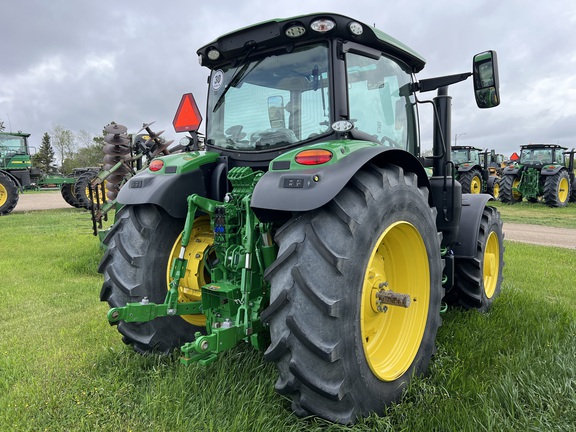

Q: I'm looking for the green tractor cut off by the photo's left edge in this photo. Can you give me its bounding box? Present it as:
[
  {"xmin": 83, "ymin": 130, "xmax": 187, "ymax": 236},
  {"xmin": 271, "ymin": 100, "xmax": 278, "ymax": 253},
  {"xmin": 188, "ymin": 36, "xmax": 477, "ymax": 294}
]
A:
[{"xmin": 0, "ymin": 132, "xmax": 98, "ymax": 216}]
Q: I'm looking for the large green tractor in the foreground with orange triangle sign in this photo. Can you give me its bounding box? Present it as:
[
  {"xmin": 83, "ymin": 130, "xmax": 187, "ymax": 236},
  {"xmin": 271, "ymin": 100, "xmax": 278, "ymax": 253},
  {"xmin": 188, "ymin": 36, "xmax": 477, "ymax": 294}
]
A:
[{"xmin": 99, "ymin": 14, "xmax": 504, "ymax": 424}]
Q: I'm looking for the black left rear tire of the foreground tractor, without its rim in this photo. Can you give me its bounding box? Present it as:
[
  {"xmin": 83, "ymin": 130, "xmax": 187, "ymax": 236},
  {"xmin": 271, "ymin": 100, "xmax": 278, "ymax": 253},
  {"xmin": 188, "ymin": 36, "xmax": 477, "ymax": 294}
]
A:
[{"xmin": 98, "ymin": 205, "xmax": 205, "ymax": 354}]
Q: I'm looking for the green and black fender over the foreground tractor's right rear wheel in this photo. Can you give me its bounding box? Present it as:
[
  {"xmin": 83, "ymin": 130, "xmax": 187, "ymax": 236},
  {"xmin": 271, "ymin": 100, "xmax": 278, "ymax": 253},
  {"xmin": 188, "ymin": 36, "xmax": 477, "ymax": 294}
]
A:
[{"xmin": 251, "ymin": 141, "xmax": 429, "ymax": 221}]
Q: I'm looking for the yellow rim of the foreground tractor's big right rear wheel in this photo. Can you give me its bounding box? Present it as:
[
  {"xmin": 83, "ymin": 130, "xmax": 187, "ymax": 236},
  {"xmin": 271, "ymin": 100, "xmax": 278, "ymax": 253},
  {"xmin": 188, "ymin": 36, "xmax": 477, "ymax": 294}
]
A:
[{"xmin": 360, "ymin": 221, "xmax": 430, "ymax": 381}]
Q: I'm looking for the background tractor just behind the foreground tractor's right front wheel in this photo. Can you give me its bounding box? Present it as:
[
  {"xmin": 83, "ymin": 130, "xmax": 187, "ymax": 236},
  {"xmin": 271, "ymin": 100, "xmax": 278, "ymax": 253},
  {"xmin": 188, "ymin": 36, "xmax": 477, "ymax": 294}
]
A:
[{"xmin": 452, "ymin": 146, "xmax": 500, "ymax": 199}]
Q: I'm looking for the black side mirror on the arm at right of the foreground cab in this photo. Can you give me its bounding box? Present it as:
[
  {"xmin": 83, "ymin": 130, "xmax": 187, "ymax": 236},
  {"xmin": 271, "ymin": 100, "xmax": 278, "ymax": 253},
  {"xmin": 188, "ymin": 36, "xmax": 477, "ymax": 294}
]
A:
[{"xmin": 472, "ymin": 51, "xmax": 500, "ymax": 108}]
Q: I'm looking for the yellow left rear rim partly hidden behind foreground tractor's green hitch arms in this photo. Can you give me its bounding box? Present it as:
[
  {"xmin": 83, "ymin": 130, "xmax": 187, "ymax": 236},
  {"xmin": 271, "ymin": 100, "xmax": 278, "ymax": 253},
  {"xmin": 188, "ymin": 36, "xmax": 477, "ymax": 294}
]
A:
[{"xmin": 166, "ymin": 216, "xmax": 214, "ymax": 326}]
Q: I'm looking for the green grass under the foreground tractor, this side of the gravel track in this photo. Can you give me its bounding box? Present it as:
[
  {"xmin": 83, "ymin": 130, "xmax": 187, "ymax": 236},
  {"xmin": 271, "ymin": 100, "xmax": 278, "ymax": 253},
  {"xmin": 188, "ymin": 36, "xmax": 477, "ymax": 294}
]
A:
[{"xmin": 0, "ymin": 209, "xmax": 576, "ymax": 432}]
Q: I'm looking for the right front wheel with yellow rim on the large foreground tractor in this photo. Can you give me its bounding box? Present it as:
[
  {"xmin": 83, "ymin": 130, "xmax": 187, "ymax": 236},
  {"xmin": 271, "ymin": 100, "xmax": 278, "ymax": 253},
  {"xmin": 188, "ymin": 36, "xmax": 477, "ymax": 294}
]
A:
[{"xmin": 446, "ymin": 207, "xmax": 504, "ymax": 312}]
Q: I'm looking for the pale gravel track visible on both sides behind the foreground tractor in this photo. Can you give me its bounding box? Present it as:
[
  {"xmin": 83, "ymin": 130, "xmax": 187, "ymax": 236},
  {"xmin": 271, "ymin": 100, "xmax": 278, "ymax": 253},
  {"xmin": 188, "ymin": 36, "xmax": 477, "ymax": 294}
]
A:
[{"xmin": 9, "ymin": 192, "xmax": 576, "ymax": 249}]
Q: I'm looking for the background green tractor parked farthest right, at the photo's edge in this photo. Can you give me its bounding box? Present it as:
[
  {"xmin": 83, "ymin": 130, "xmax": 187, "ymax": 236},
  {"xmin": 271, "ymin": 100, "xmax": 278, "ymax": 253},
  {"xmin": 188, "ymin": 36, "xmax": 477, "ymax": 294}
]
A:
[{"xmin": 500, "ymin": 144, "xmax": 576, "ymax": 207}]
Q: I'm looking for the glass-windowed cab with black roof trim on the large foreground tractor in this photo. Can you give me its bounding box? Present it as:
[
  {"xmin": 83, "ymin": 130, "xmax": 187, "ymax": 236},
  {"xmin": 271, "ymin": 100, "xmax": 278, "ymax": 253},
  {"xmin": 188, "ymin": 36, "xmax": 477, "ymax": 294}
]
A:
[{"xmin": 191, "ymin": 15, "xmax": 424, "ymax": 167}]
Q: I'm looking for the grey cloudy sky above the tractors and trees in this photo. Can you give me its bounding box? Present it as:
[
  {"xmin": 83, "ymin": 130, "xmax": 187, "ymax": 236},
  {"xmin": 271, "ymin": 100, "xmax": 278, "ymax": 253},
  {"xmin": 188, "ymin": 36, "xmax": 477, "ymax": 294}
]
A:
[{"xmin": 0, "ymin": 0, "xmax": 576, "ymax": 159}]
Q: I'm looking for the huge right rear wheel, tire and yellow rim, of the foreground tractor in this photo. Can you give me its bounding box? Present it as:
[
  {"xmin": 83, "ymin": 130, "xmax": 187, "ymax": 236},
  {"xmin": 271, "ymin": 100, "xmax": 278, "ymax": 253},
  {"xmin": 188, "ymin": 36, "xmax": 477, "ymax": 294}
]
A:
[{"xmin": 263, "ymin": 165, "xmax": 443, "ymax": 424}]
